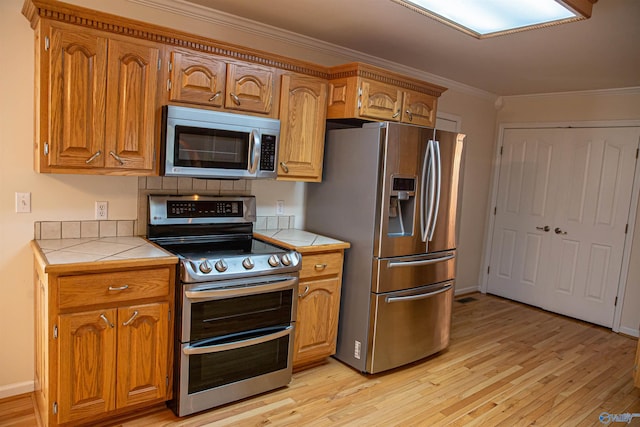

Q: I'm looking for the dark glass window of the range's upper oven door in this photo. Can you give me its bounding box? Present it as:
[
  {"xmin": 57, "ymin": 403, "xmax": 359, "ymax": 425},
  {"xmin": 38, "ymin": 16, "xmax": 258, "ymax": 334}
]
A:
[{"xmin": 189, "ymin": 289, "xmax": 293, "ymax": 342}]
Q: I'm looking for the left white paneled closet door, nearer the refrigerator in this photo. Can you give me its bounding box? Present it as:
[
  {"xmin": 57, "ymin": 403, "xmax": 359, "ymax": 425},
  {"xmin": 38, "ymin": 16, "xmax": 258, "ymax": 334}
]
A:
[{"xmin": 488, "ymin": 129, "xmax": 560, "ymax": 305}]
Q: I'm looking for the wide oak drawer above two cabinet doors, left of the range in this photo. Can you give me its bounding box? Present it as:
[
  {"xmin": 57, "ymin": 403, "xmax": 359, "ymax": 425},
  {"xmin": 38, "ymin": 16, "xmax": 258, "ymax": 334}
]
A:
[{"xmin": 58, "ymin": 267, "xmax": 170, "ymax": 308}]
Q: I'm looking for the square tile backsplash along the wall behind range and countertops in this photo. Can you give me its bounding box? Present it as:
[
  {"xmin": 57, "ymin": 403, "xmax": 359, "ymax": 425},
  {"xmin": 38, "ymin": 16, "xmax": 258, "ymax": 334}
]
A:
[{"xmin": 34, "ymin": 176, "xmax": 295, "ymax": 240}]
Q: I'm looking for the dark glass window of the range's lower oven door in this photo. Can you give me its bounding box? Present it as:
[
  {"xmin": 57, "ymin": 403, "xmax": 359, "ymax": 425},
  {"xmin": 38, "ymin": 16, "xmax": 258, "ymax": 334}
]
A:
[{"xmin": 188, "ymin": 335, "xmax": 290, "ymax": 394}]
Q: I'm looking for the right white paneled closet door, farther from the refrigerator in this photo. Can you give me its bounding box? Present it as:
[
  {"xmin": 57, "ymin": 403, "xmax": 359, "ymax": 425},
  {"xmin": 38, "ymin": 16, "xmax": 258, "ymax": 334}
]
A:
[{"xmin": 543, "ymin": 128, "xmax": 640, "ymax": 327}]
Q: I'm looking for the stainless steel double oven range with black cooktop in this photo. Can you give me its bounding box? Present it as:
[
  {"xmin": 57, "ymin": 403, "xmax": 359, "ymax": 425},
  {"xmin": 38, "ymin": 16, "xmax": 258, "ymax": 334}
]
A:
[{"xmin": 147, "ymin": 195, "xmax": 300, "ymax": 416}]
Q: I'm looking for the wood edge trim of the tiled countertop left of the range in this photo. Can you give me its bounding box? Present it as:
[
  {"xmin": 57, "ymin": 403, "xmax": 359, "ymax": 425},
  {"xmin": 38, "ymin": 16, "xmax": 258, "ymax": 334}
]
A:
[{"xmin": 30, "ymin": 239, "xmax": 178, "ymax": 274}]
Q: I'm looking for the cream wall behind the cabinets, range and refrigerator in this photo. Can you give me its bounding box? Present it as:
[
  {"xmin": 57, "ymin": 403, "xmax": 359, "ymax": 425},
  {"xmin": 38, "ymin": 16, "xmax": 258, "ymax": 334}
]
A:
[{"xmin": 0, "ymin": 0, "xmax": 496, "ymax": 398}]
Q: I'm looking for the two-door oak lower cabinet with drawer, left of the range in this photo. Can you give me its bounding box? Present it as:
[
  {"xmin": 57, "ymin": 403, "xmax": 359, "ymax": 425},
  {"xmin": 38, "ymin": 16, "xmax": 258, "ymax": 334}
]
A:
[{"xmin": 35, "ymin": 263, "xmax": 176, "ymax": 426}]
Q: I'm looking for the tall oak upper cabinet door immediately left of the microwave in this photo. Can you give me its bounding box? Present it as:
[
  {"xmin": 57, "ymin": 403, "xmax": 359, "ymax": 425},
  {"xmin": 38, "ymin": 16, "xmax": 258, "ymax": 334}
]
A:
[{"xmin": 105, "ymin": 39, "xmax": 160, "ymax": 170}]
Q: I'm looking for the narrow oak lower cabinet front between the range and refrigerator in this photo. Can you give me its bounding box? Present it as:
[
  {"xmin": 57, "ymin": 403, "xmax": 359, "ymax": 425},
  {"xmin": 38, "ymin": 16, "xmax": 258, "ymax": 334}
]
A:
[{"xmin": 293, "ymin": 249, "xmax": 344, "ymax": 370}]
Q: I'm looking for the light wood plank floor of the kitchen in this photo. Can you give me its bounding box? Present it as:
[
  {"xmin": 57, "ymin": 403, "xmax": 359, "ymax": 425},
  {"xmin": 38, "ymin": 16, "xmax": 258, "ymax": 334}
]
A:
[{"xmin": 0, "ymin": 294, "xmax": 640, "ymax": 427}]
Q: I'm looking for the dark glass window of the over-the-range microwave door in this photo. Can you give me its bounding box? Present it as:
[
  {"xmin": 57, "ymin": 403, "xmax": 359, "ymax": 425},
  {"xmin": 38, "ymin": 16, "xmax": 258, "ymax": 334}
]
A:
[{"xmin": 174, "ymin": 125, "xmax": 250, "ymax": 169}]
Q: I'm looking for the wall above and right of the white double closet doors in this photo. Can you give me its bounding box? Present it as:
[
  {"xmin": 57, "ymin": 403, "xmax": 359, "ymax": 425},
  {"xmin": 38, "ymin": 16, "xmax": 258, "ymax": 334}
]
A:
[{"xmin": 498, "ymin": 88, "xmax": 640, "ymax": 336}]
